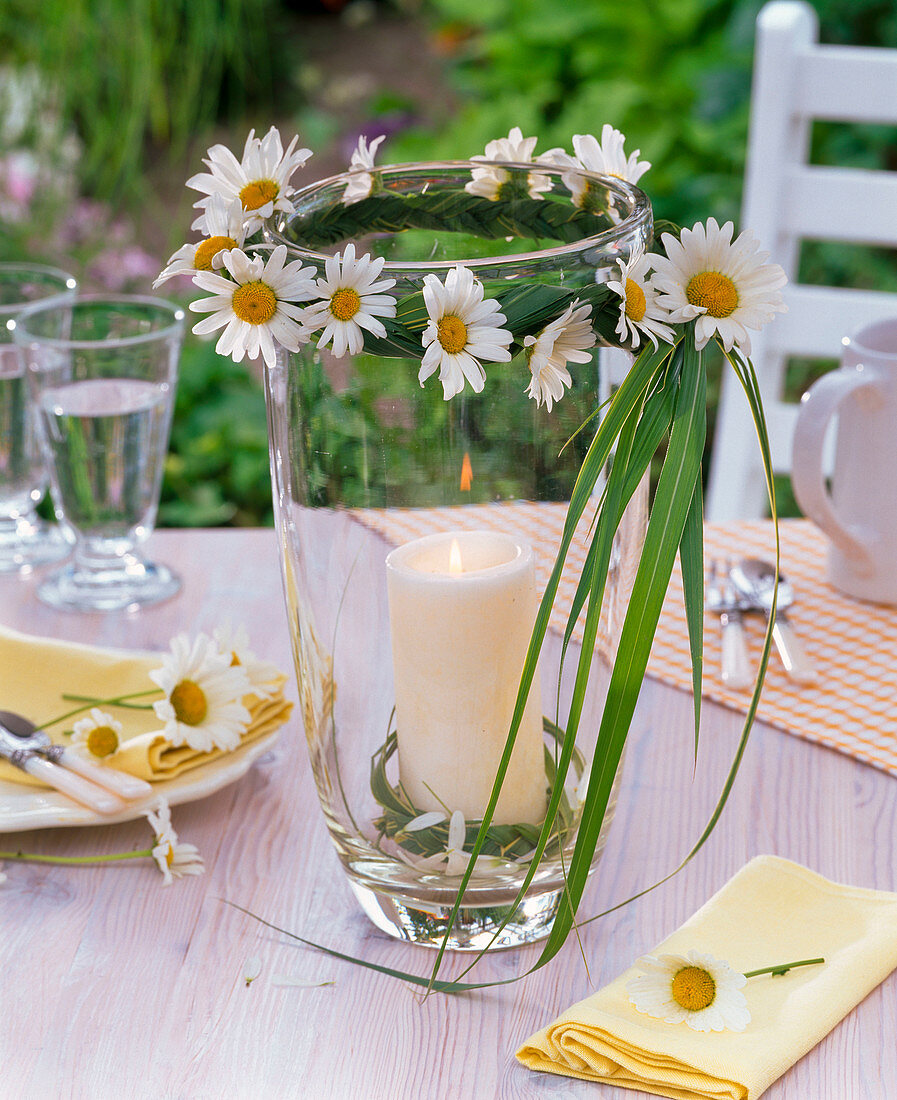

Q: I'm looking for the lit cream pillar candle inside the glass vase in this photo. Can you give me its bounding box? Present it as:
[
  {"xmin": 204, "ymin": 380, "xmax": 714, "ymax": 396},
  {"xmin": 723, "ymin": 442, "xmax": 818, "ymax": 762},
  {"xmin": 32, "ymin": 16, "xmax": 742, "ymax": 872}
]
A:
[{"xmin": 386, "ymin": 531, "xmax": 546, "ymax": 825}]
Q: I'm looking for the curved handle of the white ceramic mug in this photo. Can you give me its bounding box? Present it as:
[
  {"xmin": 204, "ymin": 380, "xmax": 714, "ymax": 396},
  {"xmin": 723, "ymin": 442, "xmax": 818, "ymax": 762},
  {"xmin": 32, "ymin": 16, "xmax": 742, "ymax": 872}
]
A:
[{"xmin": 791, "ymin": 371, "xmax": 880, "ymax": 572}]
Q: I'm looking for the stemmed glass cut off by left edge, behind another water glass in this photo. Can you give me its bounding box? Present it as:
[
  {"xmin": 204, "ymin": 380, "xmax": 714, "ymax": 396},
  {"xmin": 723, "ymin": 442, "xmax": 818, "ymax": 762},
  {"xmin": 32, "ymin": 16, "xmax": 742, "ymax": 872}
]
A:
[{"xmin": 0, "ymin": 264, "xmax": 78, "ymax": 573}]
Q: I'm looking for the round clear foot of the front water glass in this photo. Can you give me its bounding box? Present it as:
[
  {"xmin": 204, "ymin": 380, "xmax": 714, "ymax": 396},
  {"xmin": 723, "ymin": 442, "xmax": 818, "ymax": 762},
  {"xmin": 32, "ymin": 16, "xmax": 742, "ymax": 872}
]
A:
[{"xmin": 37, "ymin": 562, "xmax": 181, "ymax": 612}]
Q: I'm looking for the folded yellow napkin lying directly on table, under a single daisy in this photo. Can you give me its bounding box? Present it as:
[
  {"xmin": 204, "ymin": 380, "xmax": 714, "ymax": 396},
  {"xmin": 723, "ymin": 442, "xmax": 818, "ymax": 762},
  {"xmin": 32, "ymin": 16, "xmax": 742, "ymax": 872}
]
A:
[{"xmin": 517, "ymin": 856, "xmax": 897, "ymax": 1100}]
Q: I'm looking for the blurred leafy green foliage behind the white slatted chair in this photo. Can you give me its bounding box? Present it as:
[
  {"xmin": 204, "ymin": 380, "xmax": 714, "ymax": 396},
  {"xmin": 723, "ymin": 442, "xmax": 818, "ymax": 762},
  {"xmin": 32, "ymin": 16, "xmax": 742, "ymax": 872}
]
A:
[{"xmin": 390, "ymin": 0, "xmax": 897, "ymax": 515}]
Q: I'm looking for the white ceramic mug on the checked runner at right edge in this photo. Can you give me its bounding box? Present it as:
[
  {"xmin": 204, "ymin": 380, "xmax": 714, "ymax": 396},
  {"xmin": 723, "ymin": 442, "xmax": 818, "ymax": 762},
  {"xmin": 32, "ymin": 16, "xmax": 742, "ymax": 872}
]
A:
[{"xmin": 791, "ymin": 318, "xmax": 897, "ymax": 604}]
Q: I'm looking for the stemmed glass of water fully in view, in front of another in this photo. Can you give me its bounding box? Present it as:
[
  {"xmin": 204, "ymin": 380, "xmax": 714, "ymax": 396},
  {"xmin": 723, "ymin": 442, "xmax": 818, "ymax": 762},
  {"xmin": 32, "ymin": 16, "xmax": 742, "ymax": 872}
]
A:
[{"xmin": 15, "ymin": 296, "xmax": 184, "ymax": 611}]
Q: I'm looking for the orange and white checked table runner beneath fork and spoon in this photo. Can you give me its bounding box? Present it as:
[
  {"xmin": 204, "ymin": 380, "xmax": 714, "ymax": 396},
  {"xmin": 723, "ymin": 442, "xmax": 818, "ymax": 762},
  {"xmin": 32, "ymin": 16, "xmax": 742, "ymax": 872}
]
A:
[{"xmin": 355, "ymin": 502, "xmax": 897, "ymax": 776}]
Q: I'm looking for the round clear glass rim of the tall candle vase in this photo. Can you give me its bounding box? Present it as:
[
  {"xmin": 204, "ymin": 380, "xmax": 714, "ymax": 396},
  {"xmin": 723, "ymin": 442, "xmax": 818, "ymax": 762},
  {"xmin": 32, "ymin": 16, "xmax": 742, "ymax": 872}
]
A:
[{"xmin": 265, "ymin": 161, "xmax": 654, "ymax": 276}]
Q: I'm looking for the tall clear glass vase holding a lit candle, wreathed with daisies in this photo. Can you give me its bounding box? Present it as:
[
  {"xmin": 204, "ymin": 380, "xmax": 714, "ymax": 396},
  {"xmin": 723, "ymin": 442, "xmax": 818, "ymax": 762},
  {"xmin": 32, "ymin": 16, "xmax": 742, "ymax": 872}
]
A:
[{"xmin": 266, "ymin": 163, "xmax": 652, "ymax": 949}]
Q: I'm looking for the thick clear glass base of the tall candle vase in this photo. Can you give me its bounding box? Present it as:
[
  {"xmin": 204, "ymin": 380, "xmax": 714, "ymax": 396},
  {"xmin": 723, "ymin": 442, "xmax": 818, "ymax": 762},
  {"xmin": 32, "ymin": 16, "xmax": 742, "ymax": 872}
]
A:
[{"xmin": 349, "ymin": 879, "xmax": 562, "ymax": 952}]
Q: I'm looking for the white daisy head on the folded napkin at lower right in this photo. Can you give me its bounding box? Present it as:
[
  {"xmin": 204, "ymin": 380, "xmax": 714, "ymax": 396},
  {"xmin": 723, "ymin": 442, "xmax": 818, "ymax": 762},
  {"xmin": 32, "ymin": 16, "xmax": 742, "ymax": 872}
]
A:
[{"xmin": 626, "ymin": 952, "xmax": 751, "ymax": 1032}]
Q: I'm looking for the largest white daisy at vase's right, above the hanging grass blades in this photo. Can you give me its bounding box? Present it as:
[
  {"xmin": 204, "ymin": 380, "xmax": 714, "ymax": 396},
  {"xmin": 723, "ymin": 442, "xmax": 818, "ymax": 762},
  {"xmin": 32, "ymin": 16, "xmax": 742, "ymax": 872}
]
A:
[{"xmin": 654, "ymin": 218, "xmax": 788, "ymax": 355}]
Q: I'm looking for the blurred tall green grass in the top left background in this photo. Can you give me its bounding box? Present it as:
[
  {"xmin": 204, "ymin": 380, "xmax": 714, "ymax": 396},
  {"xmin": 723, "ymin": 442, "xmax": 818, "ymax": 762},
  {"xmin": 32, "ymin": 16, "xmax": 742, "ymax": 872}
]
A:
[{"xmin": 0, "ymin": 0, "xmax": 285, "ymax": 200}]
